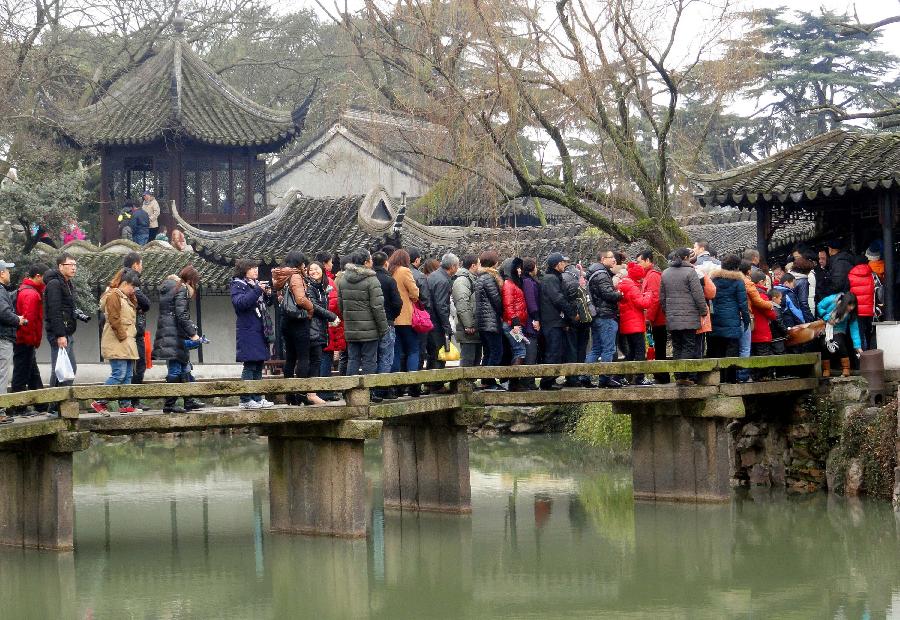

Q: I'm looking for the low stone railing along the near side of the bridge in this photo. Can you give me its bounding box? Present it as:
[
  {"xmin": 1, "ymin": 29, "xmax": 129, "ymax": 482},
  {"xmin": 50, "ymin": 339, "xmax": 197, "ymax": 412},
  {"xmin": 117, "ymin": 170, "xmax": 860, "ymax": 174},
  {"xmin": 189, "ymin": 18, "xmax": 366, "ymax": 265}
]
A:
[{"xmin": 0, "ymin": 353, "xmax": 821, "ymax": 419}]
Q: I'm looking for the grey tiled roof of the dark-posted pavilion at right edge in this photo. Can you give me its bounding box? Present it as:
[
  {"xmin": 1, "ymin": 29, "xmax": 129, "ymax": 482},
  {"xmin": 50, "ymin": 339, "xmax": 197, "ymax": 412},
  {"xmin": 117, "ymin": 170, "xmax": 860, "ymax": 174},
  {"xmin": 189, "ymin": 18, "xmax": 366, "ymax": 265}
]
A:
[{"xmin": 693, "ymin": 129, "xmax": 900, "ymax": 206}]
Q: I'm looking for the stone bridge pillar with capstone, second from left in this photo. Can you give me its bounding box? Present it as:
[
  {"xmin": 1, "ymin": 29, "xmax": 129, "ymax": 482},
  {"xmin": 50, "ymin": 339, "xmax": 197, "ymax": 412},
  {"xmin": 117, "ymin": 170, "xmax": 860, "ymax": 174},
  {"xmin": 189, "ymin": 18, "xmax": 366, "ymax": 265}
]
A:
[{"xmin": 266, "ymin": 420, "xmax": 381, "ymax": 538}]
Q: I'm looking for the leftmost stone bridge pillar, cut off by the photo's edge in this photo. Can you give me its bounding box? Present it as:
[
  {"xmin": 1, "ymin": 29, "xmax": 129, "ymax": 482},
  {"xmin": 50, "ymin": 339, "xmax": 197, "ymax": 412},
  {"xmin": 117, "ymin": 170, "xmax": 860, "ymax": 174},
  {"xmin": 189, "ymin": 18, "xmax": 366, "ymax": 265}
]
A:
[{"xmin": 0, "ymin": 433, "xmax": 90, "ymax": 551}]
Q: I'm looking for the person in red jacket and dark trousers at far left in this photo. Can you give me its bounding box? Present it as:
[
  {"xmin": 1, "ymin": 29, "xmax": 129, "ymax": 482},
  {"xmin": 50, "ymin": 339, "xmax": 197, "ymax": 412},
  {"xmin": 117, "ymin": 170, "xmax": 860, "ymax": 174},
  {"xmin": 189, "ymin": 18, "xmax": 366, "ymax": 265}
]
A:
[{"xmin": 10, "ymin": 263, "xmax": 50, "ymax": 416}]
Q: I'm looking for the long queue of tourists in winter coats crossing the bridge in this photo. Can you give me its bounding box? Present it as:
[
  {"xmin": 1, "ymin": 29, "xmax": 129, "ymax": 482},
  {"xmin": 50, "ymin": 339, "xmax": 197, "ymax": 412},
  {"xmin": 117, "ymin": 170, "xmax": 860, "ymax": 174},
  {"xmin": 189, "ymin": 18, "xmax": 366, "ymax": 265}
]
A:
[{"xmin": 0, "ymin": 235, "xmax": 884, "ymax": 423}]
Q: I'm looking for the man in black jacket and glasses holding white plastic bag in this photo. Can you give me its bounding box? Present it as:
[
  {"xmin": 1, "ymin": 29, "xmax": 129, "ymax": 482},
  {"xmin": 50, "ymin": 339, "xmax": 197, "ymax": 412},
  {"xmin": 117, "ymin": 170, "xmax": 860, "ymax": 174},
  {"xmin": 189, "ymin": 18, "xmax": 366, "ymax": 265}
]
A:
[{"xmin": 44, "ymin": 252, "xmax": 78, "ymax": 402}]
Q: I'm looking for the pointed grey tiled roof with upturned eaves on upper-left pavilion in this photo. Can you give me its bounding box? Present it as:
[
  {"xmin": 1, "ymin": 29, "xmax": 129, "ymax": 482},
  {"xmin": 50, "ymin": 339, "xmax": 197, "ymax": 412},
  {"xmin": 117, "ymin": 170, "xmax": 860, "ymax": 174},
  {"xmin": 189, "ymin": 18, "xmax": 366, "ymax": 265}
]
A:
[{"xmin": 51, "ymin": 37, "xmax": 315, "ymax": 150}]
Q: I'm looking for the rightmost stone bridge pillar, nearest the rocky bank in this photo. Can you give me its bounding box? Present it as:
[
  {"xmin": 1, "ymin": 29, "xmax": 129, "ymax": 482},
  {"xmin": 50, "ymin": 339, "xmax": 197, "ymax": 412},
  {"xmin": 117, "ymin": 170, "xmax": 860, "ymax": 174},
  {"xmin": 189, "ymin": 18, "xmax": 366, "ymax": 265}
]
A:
[{"xmin": 613, "ymin": 398, "xmax": 744, "ymax": 502}]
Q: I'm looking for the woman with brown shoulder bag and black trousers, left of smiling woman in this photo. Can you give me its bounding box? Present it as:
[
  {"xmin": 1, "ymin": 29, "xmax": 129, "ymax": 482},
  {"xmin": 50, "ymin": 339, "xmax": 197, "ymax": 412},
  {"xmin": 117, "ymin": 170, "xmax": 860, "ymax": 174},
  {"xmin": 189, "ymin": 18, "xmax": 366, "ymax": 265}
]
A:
[{"xmin": 272, "ymin": 250, "xmax": 314, "ymax": 406}]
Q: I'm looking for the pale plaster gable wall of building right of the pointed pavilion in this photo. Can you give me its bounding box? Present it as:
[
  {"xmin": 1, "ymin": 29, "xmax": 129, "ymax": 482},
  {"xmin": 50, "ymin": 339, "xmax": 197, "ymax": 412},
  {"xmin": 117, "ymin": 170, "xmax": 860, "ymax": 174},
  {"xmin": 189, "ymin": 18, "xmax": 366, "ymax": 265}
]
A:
[{"xmin": 268, "ymin": 134, "xmax": 429, "ymax": 204}]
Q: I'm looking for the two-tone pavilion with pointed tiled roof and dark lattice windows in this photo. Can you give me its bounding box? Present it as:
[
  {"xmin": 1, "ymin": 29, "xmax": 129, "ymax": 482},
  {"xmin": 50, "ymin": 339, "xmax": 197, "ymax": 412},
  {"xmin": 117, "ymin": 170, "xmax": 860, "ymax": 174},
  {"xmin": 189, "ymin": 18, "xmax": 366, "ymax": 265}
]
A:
[{"xmin": 55, "ymin": 17, "xmax": 312, "ymax": 242}]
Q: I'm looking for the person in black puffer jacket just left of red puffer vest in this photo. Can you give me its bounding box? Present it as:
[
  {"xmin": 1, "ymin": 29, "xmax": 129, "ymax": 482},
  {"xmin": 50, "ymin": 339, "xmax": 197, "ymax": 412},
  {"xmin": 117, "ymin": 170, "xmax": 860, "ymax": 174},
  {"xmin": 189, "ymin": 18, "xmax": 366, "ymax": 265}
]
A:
[{"xmin": 475, "ymin": 250, "xmax": 503, "ymax": 390}]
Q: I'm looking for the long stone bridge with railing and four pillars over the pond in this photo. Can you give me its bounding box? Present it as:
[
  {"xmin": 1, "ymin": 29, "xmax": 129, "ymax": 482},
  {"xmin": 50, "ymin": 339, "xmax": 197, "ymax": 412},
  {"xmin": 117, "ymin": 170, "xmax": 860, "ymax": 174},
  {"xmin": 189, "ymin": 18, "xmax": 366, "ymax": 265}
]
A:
[{"xmin": 0, "ymin": 355, "xmax": 819, "ymax": 549}]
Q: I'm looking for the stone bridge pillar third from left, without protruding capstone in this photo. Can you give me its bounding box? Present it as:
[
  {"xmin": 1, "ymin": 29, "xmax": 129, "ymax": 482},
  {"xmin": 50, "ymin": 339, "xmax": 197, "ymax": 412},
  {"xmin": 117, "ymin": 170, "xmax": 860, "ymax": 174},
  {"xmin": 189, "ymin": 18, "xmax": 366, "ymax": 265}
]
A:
[{"xmin": 382, "ymin": 412, "xmax": 472, "ymax": 513}]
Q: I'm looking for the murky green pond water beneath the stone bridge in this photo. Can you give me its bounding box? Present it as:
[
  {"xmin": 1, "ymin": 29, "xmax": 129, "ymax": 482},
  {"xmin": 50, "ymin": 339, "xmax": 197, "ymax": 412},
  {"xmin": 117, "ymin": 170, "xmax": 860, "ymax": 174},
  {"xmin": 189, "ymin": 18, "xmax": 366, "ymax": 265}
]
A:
[{"xmin": 0, "ymin": 436, "xmax": 900, "ymax": 620}]
